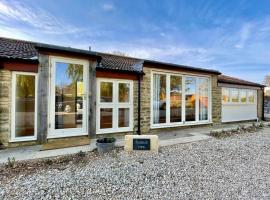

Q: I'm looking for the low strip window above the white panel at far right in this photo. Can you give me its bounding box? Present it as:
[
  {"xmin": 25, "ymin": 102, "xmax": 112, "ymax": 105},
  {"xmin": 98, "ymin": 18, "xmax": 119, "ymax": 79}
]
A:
[{"xmin": 222, "ymin": 87, "xmax": 256, "ymax": 104}]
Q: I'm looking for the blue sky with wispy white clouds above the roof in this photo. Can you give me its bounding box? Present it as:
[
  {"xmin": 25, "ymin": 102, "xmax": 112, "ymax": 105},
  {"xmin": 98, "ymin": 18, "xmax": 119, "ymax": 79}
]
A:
[{"xmin": 0, "ymin": 0, "xmax": 270, "ymax": 83}]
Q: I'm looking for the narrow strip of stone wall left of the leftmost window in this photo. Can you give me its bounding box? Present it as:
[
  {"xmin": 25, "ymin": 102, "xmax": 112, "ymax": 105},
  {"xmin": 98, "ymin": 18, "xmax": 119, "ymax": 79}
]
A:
[{"xmin": 0, "ymin": 69, "xmax": 11, "ymax": 146}]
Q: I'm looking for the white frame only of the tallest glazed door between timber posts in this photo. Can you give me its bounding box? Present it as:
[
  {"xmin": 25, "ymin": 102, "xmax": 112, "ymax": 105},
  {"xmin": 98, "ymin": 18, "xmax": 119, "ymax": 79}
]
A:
[{"xmin": 47, "ymin": 56, "xmax": 89, "ymax": 139}]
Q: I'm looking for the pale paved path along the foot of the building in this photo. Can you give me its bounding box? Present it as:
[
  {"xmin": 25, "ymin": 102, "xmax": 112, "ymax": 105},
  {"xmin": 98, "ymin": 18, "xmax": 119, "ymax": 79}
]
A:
[{"xmin": 0, "ymin": 120, "xmax": 262, "ymax": 163}]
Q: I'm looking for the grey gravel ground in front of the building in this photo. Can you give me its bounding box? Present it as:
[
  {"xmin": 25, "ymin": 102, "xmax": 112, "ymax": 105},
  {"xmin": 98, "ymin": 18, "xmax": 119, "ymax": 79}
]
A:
[{"xmin": 0, "ymin": 128, "xmax": 270, "ymax": 199}]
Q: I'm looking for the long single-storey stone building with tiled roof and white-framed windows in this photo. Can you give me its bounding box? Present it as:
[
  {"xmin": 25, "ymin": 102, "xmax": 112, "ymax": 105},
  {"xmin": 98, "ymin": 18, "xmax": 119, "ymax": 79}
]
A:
[{"xmin": 0, "ymin": 38, "xmax": 264, "ymax": 147}]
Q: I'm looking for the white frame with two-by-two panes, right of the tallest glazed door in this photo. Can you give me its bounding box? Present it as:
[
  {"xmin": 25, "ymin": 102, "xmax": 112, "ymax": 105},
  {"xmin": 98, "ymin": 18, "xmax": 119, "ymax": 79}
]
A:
[{"xmin": 96, "ymin": 78, "xmax": 133, "ymax": 134}]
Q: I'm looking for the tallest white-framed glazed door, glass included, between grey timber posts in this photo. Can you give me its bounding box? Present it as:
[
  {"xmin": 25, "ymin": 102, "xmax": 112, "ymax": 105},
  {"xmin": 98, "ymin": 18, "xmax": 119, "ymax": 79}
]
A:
[{"xmin": 48, "ymin": 57, "xmax": 89, "ymax": 138}]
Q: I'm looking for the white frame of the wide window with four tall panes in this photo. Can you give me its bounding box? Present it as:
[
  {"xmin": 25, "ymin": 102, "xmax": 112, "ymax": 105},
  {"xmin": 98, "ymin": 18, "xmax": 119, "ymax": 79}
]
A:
[{"xmin": 150, "ymin": 70, "xmax": 212, "ymax": 129}]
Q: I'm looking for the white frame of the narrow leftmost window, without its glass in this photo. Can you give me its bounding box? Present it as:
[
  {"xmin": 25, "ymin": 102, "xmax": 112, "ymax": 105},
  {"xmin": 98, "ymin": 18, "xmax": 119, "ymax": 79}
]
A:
[{"xmin": 10, "ymin": 71, "xmax": 38, "ymax": 142}]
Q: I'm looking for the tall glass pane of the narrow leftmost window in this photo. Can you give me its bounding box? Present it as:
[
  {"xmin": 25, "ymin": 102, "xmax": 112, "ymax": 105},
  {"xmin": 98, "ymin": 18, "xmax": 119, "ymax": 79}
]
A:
[{"xmin": 15, "ymin": 75, "xmax": 35, "ymax": 137}]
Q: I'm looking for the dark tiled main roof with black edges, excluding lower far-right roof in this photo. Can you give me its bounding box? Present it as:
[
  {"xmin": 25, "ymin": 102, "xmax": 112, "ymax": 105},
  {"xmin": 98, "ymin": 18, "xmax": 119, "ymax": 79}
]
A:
[{"xmin": 0, "ymin": 37, "xmax": 221, "ymax": 74}]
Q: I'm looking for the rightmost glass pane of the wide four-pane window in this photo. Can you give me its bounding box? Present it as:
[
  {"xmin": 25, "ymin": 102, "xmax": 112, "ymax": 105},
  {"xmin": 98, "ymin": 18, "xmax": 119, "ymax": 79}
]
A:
[{"xmin": 198, "ymin": 78, "xmax": 209, "ymax": 120}]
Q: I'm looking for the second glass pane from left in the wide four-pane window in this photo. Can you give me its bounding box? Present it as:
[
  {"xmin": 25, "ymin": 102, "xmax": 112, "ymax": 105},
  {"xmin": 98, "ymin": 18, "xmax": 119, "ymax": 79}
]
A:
[{"xmin": 170, "ymin": 76, "xmax": 182, "ymax": 122}]
